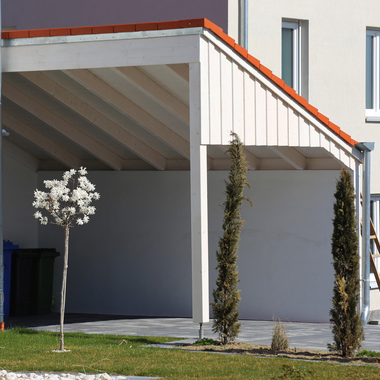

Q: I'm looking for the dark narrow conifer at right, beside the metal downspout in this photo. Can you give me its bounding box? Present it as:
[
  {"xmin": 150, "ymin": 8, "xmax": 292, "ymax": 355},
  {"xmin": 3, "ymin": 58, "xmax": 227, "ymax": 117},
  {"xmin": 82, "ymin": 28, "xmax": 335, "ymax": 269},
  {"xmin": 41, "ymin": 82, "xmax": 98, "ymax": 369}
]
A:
[{"xmin": 328, "ymin": 169, "xmax": 363, "ymax": 357}]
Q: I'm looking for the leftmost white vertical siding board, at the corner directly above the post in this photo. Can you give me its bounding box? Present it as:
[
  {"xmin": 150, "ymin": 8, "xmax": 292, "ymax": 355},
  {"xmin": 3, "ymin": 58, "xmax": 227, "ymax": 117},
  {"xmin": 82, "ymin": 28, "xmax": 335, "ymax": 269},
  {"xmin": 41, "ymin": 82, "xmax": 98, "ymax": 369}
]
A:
[{"xmin": 200, "ymin": 38, "xmax": 210, "ymax": 144}]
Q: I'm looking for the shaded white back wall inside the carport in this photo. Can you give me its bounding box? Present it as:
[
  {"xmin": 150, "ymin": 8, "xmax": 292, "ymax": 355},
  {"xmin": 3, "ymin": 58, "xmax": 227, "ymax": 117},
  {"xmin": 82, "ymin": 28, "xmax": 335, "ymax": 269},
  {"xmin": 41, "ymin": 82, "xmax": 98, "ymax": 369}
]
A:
[{"xmin": 38, "ymin": 171, "xmax": 339, "ymax": 322}]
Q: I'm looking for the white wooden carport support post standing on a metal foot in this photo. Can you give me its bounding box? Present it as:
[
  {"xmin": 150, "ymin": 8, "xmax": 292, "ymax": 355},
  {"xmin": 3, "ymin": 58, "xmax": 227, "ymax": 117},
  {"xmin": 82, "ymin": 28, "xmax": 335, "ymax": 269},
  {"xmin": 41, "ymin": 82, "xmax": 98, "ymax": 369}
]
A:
[{"xmin": 189, "ymin": 63, "xmax": 209, "ymax": 326}]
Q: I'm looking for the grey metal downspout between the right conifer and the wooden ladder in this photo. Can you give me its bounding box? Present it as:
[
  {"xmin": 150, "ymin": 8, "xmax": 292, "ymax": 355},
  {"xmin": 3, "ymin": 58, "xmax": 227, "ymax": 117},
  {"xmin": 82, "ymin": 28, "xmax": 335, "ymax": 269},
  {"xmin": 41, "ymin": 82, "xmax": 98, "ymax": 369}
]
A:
[{"xmin": 355, "ymin": 142, "xmax": 375, "ymax": 325}]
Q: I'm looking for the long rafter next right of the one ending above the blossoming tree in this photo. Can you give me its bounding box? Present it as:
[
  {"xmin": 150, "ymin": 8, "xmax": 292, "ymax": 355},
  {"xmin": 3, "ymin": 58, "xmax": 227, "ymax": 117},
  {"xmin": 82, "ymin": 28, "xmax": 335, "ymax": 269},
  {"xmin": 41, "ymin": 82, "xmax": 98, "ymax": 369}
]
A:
[{"xmin": 3, "ymin": 80, "xmax": 123, "ymax": 170}]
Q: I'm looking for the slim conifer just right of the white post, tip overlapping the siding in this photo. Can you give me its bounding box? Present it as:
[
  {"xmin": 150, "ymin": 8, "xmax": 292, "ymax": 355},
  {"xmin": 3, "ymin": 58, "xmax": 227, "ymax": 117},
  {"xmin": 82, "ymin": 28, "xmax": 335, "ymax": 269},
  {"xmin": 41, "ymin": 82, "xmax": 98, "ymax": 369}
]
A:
[{"xmin": 211, "ymin": 133, "xmax": 251, "ymax": 344}]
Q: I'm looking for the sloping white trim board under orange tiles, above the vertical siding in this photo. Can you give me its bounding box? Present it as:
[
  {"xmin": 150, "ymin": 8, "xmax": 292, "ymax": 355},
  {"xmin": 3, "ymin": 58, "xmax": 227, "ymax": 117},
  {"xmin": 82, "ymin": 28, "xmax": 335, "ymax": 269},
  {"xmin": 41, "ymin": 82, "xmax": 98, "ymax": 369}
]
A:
[{"xmin": 203, "ymin": 30, "xmax": 363, "ymax": 163}]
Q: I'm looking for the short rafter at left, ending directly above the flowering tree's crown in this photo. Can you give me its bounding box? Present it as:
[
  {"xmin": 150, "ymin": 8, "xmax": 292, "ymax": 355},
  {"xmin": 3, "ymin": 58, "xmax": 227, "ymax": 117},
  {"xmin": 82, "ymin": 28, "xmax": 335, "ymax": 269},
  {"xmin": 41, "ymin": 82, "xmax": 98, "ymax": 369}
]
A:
[{"xmin": 2, "ymin": 111, "xmax": 80, "ymax": 168}]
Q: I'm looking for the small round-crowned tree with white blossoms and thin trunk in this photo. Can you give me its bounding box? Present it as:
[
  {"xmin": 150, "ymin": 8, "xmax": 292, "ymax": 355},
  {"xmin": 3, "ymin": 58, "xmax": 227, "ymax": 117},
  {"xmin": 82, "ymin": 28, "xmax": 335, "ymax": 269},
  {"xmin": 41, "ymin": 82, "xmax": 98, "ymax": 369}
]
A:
[{"xmin": 33, "ymin": 167, "xmax": 100, "ymax": 351}]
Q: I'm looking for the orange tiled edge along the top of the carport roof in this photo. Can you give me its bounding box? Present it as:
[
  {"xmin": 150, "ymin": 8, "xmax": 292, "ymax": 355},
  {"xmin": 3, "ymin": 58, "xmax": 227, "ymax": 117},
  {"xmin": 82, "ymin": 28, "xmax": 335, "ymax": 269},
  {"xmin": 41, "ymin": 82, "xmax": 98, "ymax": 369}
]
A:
[{"xmin": 1, "ymin": 18, "xmax": 357, "ymax": 146}]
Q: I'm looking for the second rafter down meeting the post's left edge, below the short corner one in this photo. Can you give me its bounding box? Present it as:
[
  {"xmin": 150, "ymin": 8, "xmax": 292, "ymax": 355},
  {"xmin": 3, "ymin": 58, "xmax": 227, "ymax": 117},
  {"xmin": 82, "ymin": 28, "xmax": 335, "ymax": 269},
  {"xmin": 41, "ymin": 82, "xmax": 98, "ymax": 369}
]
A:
[{"xmin": 111, "ymin": 67, "xmax": 189, "ymax": 125}]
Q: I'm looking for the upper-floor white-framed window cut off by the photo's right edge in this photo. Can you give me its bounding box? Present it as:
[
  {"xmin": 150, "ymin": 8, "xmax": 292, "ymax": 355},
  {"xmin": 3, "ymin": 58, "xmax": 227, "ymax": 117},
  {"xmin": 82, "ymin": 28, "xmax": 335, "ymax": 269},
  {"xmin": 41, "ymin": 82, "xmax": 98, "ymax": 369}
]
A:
[{"xmin": 366, "ymin": 30, "xmax": 380, "ymax": 121}]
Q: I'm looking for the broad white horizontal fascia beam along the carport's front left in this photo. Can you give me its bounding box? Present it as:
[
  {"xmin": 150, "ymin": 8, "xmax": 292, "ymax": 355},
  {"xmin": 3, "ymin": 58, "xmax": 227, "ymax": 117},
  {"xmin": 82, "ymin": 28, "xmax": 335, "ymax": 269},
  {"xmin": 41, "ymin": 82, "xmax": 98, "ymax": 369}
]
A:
[{"xmin": 2, "ymin": 28, "xmax": 202, "ymax": 72}]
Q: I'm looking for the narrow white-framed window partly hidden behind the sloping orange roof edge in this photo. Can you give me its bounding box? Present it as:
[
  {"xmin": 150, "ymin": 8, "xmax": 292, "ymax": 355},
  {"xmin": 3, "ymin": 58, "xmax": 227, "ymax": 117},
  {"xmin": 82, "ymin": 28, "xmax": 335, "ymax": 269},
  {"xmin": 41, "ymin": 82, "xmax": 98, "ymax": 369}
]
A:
[{"xmin": 281, "ymin": 20, "xmax": 308, "ymax": 98}]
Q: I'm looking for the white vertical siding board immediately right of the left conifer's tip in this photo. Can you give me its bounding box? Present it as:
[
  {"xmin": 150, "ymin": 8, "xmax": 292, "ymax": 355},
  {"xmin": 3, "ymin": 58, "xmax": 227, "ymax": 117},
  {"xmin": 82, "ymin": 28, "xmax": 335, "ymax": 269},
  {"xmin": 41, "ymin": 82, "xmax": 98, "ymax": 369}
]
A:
[{"xmin": 244, "ymin": 71, "xmax": 256, "ymax": 145}]
